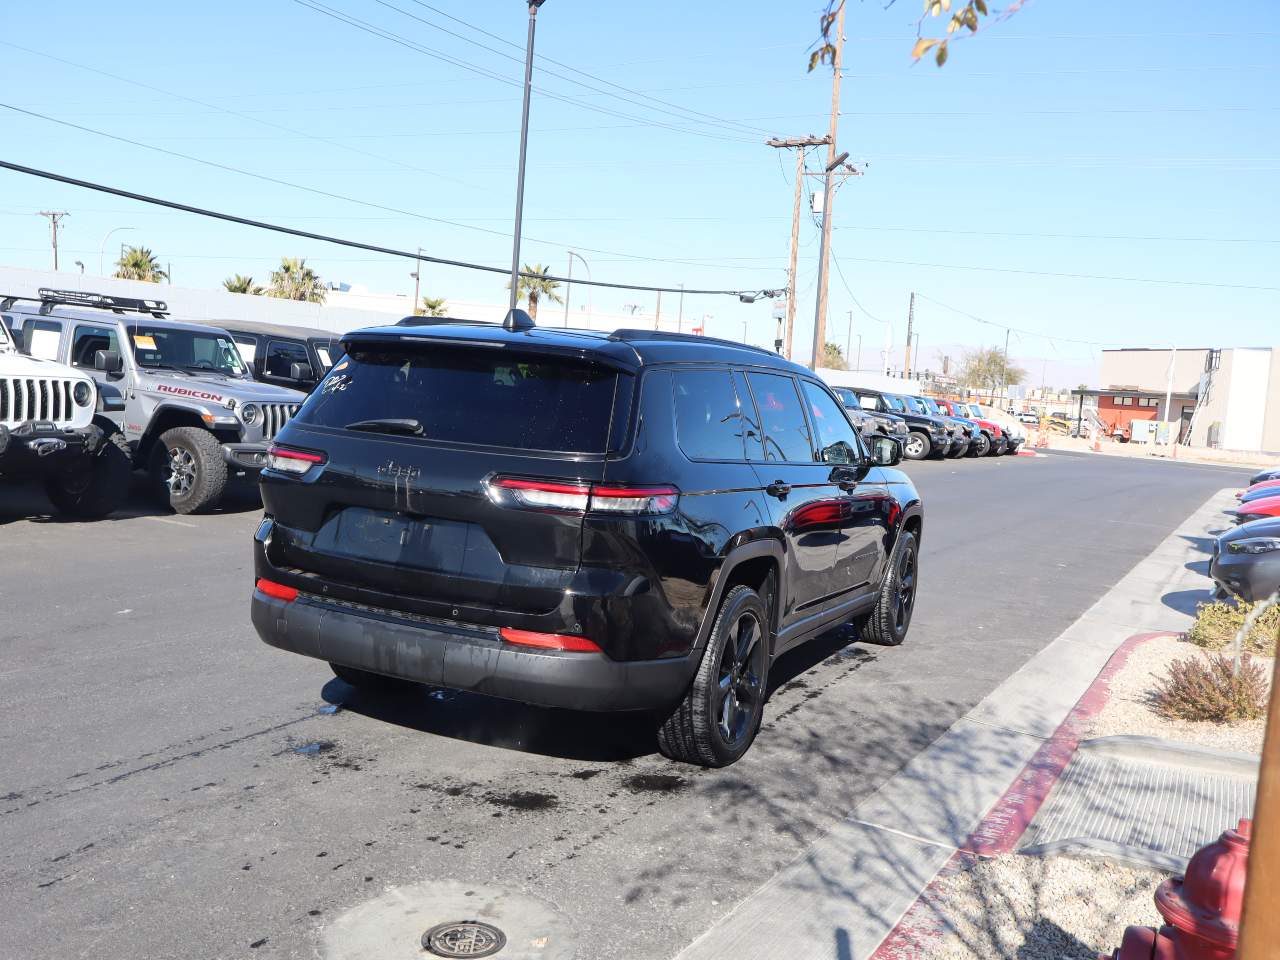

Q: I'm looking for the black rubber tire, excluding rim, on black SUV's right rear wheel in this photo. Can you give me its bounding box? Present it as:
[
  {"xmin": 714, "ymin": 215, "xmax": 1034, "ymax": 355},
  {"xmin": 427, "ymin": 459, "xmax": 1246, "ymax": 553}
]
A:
[{"xmin": 658, "ymin": 584, "xmax": 769, "ymax": 767}]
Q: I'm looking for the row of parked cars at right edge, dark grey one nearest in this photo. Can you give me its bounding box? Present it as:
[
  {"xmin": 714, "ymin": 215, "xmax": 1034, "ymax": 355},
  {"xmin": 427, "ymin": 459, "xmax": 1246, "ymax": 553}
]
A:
[{"xmin": 1210, "ymin": 467, "xmax": 1280, "ymax": 603}]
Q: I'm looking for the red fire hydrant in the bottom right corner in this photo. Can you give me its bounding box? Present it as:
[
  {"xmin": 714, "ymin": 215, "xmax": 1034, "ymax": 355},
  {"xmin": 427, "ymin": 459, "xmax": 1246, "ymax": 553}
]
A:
[{"xmin": 1100, "ymin": 820, "xmax": 1253, "ymax": 960}]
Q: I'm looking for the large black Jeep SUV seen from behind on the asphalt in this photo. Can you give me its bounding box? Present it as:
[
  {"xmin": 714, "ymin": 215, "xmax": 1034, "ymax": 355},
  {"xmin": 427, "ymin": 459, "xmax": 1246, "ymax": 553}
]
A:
[{"xmin": 252, "ymin": 320, "xmax": 923, "ymax": 767}]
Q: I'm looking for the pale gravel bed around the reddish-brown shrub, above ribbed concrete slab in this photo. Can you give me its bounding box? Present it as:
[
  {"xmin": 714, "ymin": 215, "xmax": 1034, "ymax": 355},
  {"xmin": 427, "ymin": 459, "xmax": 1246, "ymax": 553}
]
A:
[{"xmin": 1087, "ymin": 636, "xmax": 1272, "ymax": 754}]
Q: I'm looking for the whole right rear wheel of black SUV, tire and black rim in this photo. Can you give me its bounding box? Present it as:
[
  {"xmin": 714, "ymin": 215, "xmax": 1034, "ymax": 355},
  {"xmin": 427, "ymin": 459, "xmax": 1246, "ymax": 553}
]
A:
[{"xmin": 658, "ymin": 584, "xmax": 769, "ymax": 767}]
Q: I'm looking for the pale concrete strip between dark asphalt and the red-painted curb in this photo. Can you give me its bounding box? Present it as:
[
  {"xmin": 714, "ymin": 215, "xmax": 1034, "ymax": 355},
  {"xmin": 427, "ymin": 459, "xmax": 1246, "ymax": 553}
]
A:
[{"xmin": 677, "ymin": 489, "xmax": 1235, "ymax": 960}]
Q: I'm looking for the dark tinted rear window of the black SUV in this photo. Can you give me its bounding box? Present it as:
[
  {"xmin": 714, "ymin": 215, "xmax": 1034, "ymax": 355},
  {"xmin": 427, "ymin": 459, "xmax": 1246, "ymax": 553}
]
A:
[{"xmin": 297, "ymin": 344, "xmax": 631, "ymax": 453}]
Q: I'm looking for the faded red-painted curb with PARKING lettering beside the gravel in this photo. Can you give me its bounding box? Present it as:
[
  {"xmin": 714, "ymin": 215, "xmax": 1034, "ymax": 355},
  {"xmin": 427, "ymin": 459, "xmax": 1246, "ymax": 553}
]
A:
[{"xmin": 870, "ymin": 631, "xmax": 1178, "ymax": 960}]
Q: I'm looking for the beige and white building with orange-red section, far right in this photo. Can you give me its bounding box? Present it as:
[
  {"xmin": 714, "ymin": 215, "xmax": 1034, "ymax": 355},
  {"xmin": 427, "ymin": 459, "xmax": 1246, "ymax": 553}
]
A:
[{"xmin": 1080, "ymin": 347, "xmax": 1280, "ymax": 452}]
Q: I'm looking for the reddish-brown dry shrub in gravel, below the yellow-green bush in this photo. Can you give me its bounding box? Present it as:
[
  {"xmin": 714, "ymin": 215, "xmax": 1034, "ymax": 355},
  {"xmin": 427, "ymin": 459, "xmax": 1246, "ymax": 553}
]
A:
[{"xmin": 1152, "ymin": 654, "xmax": 1267, "ymax": 723}]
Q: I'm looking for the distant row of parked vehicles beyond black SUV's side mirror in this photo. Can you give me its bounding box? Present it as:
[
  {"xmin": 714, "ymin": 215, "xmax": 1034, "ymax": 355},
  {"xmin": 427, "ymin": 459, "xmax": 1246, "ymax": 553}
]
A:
[{"xmin": 832, "ymin": 387, "xmax": 1027, "ymax": 468}]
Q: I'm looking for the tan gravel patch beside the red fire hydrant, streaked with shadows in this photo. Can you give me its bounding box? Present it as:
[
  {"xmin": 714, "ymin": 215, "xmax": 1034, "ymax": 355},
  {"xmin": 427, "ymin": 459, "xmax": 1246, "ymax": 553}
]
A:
[{"xmin": 928, "ymin": 854, "xmax": 1165, "ymax": 960}]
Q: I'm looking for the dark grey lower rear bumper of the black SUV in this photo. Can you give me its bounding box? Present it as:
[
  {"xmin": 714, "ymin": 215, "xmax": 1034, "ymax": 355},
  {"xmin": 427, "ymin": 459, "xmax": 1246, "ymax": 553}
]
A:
[{"xmin": 252, "ymin": 590, "xmax": 696, "ymax": 712}]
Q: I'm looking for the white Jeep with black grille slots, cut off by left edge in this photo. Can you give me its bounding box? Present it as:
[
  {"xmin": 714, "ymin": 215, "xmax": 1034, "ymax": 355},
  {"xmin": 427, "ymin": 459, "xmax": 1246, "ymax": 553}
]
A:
[{"xmin": 0, "ymin": 308, "xmax": 131, "ymax": 518}]
